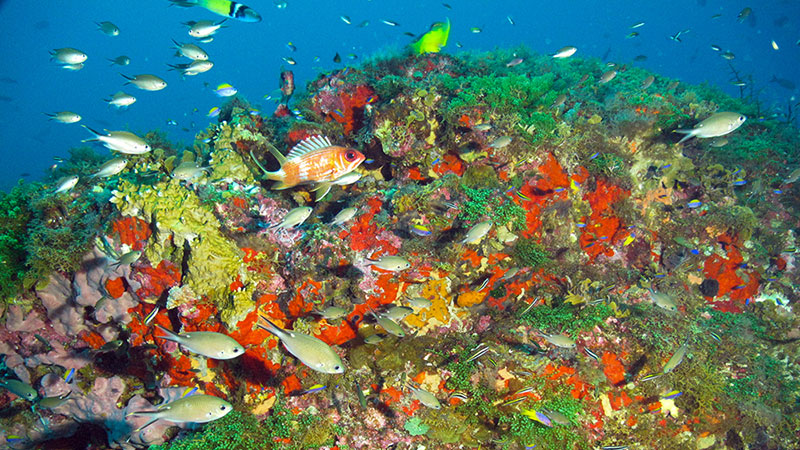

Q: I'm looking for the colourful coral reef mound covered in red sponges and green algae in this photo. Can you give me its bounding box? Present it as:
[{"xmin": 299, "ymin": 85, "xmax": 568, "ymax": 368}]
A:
[{"xmin": 0, "ymin": 48, "xmax": 800, "ymax": 450}]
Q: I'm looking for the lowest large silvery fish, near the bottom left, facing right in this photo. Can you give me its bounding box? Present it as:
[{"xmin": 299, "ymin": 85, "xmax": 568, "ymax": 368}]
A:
[{"xmin": 128, "ymin": 394, "xmax": 233, "ymax": 432}]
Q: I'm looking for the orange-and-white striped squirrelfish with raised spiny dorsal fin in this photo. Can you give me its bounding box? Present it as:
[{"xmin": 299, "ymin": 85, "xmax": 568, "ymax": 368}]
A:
[{"xmin": 261, "ymin": 136, "xmax": 365, "ymax": 201}]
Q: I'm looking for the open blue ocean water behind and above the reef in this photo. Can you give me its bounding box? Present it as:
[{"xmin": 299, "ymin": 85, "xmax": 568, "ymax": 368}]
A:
[{"xmin": 0, "ymin": 0, "xmax": 800, "ymax": 191}]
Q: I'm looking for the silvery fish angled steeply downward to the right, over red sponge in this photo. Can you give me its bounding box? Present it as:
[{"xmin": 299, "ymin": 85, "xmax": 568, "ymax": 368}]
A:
[{"xmin": 258, "ymin": 315, "xmax": 344, "ymax": 373}]
